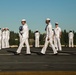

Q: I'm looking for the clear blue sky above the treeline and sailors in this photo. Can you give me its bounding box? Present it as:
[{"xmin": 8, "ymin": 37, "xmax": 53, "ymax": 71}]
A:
[{"xmin": 0, "ymin": 0, "xmax": 76, "ymax": 33}]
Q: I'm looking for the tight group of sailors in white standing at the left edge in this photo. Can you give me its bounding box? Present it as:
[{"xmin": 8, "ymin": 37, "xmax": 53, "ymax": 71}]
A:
[{"xmin": 0, "ymin": 28, "xmax": 10, "ymax": 50}]
